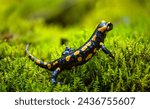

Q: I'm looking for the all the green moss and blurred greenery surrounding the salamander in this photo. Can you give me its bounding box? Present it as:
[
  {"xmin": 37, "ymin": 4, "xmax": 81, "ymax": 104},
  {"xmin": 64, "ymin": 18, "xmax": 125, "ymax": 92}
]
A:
[{"xmin": 0, "ymin": 0, "xmax": 150, "ymax": 91}]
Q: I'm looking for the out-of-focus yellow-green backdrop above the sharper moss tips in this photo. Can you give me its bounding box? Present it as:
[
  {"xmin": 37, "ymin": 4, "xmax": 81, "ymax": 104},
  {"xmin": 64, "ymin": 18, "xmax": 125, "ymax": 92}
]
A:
[{"xmin": 0, "ymin": 0, "xmax": 150, "ymax": 41}]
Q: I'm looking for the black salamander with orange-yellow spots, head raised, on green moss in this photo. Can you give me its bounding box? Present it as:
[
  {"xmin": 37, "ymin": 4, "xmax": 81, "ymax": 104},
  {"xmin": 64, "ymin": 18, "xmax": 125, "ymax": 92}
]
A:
[{"xmin": 26, "ymin": 21, "xmax": 114, "ymax": 84}]
